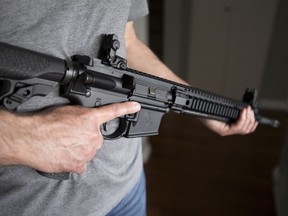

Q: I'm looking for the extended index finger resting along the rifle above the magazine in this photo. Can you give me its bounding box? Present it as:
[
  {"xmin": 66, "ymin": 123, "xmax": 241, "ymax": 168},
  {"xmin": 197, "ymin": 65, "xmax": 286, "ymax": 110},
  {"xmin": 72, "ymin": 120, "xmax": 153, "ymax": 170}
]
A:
[{"xmin": 97, "ymin": 102, "xmax": 141, "ymax": 124}]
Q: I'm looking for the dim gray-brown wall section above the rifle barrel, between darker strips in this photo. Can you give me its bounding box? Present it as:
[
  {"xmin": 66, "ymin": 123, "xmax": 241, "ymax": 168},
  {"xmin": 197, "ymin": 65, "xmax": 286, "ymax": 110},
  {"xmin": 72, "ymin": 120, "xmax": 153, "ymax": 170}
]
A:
[{"xmin": 164, "ymin": 0, "xmax": 288, "ymax": 108}]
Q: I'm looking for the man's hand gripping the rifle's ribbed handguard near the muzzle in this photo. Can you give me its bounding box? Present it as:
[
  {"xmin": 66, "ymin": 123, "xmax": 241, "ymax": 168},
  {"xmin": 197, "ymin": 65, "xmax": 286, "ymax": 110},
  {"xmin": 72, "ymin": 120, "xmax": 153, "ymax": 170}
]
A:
[{"xmin": 202, "ymin": 106, "xmax": 258, "ymax": 136}]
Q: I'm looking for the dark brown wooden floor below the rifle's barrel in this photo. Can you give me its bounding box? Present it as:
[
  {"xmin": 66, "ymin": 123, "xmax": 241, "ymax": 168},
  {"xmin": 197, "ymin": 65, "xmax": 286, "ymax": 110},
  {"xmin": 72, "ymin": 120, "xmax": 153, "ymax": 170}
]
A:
[{"xmin": 145, "ymin": 111, "xmax": 288, "ymax": 216}]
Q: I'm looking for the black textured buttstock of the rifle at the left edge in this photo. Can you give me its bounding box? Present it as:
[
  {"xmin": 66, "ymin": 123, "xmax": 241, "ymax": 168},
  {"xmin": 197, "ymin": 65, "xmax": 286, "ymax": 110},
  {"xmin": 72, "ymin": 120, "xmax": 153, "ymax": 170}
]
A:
[{"xmin": 0, "ymin": 43, "xmax": 65, "ymax": 80}]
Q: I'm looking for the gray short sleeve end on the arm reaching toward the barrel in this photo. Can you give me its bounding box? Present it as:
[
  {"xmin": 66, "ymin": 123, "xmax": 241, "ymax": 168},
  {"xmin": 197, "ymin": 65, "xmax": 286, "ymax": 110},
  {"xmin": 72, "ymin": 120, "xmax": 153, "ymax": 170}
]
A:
[{"xmin": 128, "ymin": 0, "xmax": 149, "ymax": 21}]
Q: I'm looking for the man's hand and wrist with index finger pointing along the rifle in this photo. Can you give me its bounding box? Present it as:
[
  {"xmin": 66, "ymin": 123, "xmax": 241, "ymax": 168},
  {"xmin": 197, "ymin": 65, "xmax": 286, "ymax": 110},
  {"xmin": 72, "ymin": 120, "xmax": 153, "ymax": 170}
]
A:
[{"xmin": 0, "ymin": 102, "xmax": 140, "ymax": 173}]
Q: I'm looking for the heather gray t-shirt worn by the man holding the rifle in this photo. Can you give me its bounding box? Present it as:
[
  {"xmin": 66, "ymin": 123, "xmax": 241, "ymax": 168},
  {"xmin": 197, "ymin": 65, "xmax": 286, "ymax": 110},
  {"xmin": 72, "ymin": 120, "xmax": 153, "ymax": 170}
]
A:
[{"xmin": 0, "ymin": 0, "xmax": 148, "ymax": 216}]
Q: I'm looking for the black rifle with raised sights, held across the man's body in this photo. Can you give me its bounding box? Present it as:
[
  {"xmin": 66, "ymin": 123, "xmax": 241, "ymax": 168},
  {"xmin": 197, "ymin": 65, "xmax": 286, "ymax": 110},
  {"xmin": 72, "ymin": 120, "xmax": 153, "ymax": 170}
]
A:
[{"xmin": 0, "ymin": 35, "xmax": 279, "ymax": 179}]
